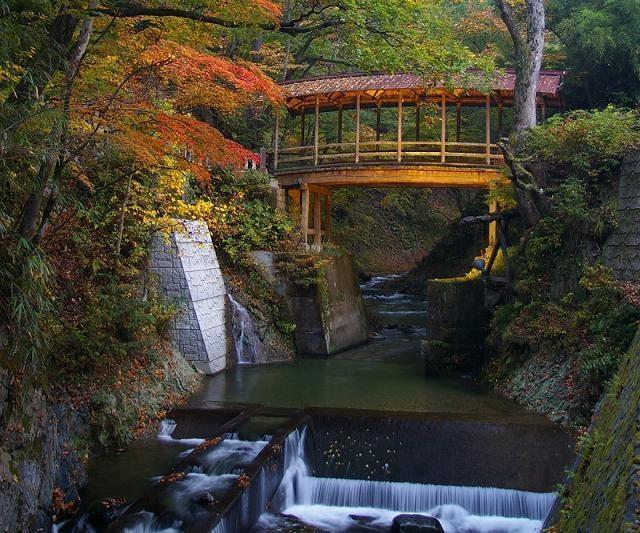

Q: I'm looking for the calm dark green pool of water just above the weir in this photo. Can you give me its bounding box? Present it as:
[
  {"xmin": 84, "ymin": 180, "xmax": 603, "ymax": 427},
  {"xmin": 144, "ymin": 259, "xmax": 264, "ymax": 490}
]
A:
[{"xmin": 190, "ymin": 359, "xmax": 544, "ymax": 423}]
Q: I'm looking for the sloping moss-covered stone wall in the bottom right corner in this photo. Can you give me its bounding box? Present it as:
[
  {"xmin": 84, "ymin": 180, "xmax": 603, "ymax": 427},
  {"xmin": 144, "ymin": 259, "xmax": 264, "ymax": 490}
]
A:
[{"xmin": 550, "ymin": 330, "xmax": 640, "ymax": 533}]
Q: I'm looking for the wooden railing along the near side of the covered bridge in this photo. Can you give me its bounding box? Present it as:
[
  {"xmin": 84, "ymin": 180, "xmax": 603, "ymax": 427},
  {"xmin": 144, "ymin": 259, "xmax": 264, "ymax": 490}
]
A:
[{"xmin": 273, "ymin": 141, "xmax": 503, "ymax": 170}]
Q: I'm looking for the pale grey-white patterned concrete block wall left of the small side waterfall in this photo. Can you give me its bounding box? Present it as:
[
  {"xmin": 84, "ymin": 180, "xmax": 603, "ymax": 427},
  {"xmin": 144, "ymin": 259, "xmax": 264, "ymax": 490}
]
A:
[{"xmin": 151, "ymin": 221, "xmax": 228, "ymax": 374}]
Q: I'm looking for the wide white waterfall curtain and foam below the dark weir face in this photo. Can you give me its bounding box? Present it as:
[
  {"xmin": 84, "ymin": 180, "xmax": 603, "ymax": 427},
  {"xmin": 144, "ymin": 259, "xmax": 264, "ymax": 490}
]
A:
[{"xmin": 256, "ymin": 430, "xmax": 557, "ymax": 533}]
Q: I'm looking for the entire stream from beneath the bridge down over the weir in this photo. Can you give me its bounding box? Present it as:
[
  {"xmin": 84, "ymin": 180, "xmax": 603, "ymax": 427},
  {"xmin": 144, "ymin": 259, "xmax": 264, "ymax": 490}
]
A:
[{"xmin": 50, "ymin": 276, "xmax": 572, "ymax": 533}]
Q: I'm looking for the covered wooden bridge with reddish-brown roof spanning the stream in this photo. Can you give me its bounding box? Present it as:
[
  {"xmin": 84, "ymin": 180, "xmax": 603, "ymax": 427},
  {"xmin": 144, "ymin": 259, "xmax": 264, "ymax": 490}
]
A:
[{"xmin": 272, "ymin": 71, "xmax": 564, "ymax": 246}]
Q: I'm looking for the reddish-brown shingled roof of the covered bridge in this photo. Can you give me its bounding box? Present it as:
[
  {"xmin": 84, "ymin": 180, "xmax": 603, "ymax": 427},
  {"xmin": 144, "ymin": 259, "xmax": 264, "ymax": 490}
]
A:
[{"xmin": 282, "ymin": 69, "xmax": 565, "ymax": 110}]
